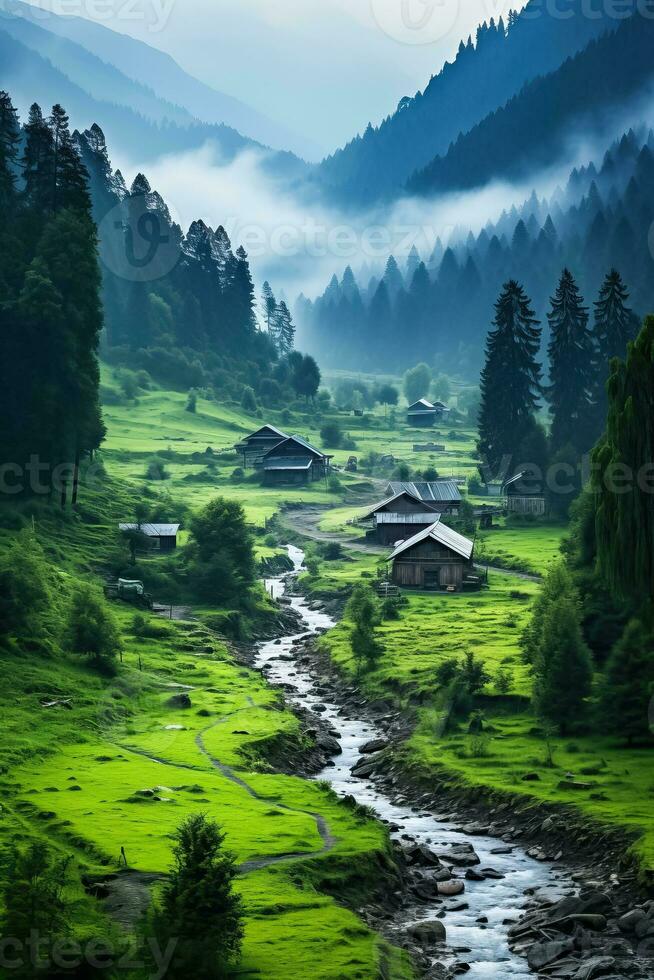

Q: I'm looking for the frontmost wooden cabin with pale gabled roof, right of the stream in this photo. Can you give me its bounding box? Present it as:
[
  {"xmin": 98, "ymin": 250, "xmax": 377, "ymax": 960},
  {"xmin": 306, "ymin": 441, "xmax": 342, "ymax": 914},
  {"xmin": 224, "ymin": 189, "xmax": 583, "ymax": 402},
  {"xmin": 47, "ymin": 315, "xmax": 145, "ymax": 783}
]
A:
[{"xmin": 388, "ymin": 518, "xmax": 481, "ymax": 592}]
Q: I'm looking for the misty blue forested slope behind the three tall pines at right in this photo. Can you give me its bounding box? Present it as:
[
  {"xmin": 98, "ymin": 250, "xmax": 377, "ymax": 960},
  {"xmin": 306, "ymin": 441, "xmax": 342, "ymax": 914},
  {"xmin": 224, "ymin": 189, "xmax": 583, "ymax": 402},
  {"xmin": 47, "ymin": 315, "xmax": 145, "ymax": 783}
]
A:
[{"xmin": 295, "ymin": 129, "xmax": 654, "ymax": 377}]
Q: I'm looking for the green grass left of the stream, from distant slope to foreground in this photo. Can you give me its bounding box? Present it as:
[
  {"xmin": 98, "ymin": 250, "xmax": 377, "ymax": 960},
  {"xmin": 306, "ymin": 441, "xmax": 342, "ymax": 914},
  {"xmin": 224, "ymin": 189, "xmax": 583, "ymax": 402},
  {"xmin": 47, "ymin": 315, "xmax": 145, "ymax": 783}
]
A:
[{"xmin": 0, "ymin": 379, "xmax": 422, "ymax": 980}]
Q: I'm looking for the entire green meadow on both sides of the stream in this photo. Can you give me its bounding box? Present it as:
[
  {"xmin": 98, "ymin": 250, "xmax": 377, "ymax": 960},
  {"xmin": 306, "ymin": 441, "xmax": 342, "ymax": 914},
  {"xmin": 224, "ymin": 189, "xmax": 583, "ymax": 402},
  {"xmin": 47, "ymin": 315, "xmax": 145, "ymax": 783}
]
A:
[{"xmin": 0, "ymin": 368, "xmax": 654, "ymax": 980}]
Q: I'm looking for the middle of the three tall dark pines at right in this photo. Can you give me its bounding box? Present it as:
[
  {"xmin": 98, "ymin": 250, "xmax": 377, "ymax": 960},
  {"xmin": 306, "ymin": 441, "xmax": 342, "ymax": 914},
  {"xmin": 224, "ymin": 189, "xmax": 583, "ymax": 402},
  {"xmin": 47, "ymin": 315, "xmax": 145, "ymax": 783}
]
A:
[{"xmin": 547, "ymin": 269, "xmax": 594, "ymax": 455}]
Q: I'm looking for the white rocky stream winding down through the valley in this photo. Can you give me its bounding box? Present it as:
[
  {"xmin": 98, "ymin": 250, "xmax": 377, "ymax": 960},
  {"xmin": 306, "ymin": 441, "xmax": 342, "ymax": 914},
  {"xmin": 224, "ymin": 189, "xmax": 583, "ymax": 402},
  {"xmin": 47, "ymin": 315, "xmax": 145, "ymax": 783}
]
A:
[{"xmin": 258, "ymin": 547, "xmax": 574, "ymax": 980}]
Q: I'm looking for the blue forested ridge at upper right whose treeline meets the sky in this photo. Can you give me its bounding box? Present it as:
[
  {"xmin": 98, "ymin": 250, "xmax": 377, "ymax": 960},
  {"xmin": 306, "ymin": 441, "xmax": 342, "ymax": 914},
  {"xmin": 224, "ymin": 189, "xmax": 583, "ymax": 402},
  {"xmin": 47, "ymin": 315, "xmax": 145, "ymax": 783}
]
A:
[{"xmin": 314, "ymin": 0, "xmax": 620, "ymax": 203}]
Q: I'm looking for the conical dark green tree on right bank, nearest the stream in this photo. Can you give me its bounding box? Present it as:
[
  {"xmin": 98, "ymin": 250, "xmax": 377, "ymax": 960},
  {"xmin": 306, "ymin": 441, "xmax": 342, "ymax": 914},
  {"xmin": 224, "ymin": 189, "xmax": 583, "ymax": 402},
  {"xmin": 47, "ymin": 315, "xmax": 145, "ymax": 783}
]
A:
[{"xmin": 534, "ymin": 596, "xmax": 593, "ymax": 736}]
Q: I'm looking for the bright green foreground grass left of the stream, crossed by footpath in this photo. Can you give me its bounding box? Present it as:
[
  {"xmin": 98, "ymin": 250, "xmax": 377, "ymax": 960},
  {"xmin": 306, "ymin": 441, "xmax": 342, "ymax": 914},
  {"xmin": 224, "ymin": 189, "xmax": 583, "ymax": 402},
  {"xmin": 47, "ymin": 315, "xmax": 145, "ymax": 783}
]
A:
[{"xmin": 0, "ymin": 611, "xmax": 408, "ymax": 980}]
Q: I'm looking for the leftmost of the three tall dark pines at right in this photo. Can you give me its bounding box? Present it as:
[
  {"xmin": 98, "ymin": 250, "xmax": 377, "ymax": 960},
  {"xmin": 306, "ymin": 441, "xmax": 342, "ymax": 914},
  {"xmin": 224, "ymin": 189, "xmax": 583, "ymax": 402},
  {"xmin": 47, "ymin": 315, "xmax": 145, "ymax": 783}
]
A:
[{"xmin": 478, "ymin": 280, "xmax": 541, "ymax": 471}]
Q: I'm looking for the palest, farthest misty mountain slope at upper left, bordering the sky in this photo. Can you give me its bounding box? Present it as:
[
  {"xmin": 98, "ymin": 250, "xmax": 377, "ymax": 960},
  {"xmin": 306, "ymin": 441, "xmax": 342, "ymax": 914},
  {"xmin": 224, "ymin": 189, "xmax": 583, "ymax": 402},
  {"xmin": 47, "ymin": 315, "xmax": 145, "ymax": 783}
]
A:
[{"xmin": 0, "ymin": 0, "xmax": 310, "ymax": 155}]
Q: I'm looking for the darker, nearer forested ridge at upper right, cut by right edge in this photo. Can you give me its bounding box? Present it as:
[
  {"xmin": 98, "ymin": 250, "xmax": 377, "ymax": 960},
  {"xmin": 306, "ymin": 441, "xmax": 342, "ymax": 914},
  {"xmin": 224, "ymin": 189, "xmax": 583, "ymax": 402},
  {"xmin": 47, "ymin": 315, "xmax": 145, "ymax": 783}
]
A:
[{"xmin": 408, "ymin": 15, "xmax": 654, "ymax": 194}]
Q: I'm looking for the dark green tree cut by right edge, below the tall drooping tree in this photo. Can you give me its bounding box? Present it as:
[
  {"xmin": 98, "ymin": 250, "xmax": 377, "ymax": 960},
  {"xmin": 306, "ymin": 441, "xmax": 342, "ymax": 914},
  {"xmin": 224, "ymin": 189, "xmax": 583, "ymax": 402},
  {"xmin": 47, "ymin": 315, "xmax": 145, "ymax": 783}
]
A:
[{"xmin": 600, "ymin": 619, "xmax": 654, "ymax": 745}]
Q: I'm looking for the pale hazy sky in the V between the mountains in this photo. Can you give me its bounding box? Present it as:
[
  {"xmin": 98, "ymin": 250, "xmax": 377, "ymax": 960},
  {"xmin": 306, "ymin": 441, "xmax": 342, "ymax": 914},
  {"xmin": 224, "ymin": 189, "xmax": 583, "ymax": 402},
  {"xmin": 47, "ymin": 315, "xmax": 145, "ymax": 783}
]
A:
[{"xmin": 23, "ymin": 0, "xmax": 526, "ymax": 156}]
